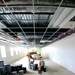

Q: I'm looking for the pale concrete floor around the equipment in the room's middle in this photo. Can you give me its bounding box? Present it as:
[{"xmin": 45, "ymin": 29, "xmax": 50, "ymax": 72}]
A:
[{"xmin": 12, "ymin": 57, "xmax": 75, "ymax": 75}]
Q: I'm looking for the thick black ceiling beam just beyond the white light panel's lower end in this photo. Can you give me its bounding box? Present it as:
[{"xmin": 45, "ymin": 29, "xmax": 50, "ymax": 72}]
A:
[{"xmin": 3, "ymin": 28, "xmax": 69, "ymax": 32}]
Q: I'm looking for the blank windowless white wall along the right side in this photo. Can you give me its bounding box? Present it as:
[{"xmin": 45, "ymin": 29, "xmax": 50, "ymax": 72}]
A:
[{"xmin": 42, "ymin": 34, "xmax": 75, "ymax": 73}]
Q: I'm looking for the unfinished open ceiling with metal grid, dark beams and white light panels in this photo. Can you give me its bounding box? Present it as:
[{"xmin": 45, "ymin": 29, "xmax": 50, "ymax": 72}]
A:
[{"xmin": 0, "ymin": 0, "xmax": 75, "ymax": 47}]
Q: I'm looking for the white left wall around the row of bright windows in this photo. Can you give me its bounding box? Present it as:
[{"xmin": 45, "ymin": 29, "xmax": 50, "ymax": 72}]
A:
[{"xmin": 0, "ymin": 41, "xmax": 27, "ymax": 64}]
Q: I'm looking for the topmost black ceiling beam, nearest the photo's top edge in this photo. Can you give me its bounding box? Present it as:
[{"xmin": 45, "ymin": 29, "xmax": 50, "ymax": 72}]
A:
[{"xmin": 0, "ymin": 2, "xmax": 75, "ymax": 8}]
